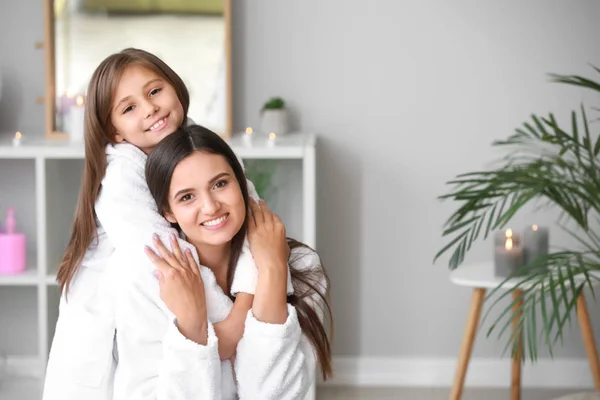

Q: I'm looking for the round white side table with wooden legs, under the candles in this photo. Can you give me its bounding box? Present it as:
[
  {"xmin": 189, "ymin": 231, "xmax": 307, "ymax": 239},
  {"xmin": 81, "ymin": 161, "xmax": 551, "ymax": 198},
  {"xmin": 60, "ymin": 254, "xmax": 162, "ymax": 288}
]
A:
[{"xmin": 450, "ymin": 262, "xmax": 600, "ymax": 400}]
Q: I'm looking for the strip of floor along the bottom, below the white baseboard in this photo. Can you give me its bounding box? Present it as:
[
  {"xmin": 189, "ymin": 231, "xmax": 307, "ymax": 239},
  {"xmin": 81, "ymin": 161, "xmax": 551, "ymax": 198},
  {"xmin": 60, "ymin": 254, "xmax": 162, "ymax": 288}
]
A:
[{"xmin": 0, "ymin": 380, "xmax": 599, "ymax": 400}]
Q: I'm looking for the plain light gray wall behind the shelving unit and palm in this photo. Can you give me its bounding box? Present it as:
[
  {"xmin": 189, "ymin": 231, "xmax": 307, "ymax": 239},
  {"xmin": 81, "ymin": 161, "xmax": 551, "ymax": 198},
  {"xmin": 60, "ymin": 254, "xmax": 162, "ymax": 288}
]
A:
[{"xmin": 0, "ymin": 0, "xmax": 600, "ymax": 357}]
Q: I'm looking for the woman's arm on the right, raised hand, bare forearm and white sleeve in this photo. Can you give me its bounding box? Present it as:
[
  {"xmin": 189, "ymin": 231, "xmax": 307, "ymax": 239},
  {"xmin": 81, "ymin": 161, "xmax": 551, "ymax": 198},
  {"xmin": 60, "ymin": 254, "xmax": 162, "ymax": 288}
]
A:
[{"xmin": 235, "ymin": 202, "xmax": 326, "ymax": 400}]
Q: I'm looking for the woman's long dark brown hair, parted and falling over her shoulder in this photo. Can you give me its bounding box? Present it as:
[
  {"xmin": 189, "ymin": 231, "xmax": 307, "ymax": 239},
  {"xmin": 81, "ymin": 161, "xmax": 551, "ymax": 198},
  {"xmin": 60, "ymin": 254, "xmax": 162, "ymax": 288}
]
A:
[{"xmin": 146, "ymin": 125, "xmax": 333, "ymax": 380}]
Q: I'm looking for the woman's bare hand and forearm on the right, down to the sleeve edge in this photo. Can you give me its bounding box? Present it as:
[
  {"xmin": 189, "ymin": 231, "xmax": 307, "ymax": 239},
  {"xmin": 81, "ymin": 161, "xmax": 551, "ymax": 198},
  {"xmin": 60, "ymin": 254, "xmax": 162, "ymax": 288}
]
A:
[{"xmin": 248, "ymin": 200, "xmax": 290, "ymax": 324}]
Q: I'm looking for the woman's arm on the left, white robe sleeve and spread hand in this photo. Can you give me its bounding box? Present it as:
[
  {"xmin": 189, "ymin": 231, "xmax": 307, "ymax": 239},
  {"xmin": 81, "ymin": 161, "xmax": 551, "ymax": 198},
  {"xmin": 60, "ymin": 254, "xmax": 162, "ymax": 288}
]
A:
[{"xmin": 111, "ymin": 239, "xmax": 221, "ymax": 400}]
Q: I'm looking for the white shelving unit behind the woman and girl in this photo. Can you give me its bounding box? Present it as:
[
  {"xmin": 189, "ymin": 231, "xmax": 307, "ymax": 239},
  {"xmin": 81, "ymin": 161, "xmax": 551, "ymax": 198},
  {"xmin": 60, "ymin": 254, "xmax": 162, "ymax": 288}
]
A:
[{"xmin": 0, "ymin": 133, "xmax": 316, "ymax": 400}]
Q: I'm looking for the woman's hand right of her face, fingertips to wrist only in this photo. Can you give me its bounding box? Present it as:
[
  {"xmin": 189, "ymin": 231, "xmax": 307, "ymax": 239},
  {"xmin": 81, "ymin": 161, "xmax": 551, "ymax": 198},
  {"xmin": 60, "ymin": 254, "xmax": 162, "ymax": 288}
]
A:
[{"xmin": 248, "ymin": 199, "xmax": 290, "ymax": 271}]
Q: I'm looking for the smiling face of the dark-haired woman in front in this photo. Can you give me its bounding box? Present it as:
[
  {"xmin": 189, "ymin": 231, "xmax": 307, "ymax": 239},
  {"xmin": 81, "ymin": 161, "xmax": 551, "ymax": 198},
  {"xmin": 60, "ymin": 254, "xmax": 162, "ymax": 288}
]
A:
[{"xmin": 165, "ymin": 151, "xmax": 246, "ymax": 246}]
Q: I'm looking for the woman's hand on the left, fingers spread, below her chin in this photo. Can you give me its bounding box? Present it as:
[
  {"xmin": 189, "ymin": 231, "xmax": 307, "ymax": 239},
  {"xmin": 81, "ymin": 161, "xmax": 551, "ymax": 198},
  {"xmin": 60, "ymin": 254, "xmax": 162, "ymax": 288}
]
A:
[{"xmin": 145, "ymin": 234, "xmax": 208, "ymax": 345}]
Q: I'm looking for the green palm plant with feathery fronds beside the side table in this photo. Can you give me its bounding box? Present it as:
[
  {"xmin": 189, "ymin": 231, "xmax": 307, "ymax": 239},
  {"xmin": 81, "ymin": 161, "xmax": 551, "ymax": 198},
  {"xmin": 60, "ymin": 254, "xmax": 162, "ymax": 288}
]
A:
[{"xmin": 435, "ymin": 68, "xmax": 600, "ymax": 361}]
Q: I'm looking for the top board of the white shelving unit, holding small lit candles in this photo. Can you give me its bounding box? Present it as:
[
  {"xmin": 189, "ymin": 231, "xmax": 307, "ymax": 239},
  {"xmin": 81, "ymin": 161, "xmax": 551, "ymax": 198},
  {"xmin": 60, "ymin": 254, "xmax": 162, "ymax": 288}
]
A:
[{"xmin": 0, "ymin": 132, "xmax": 315, "ymax": 159}]
